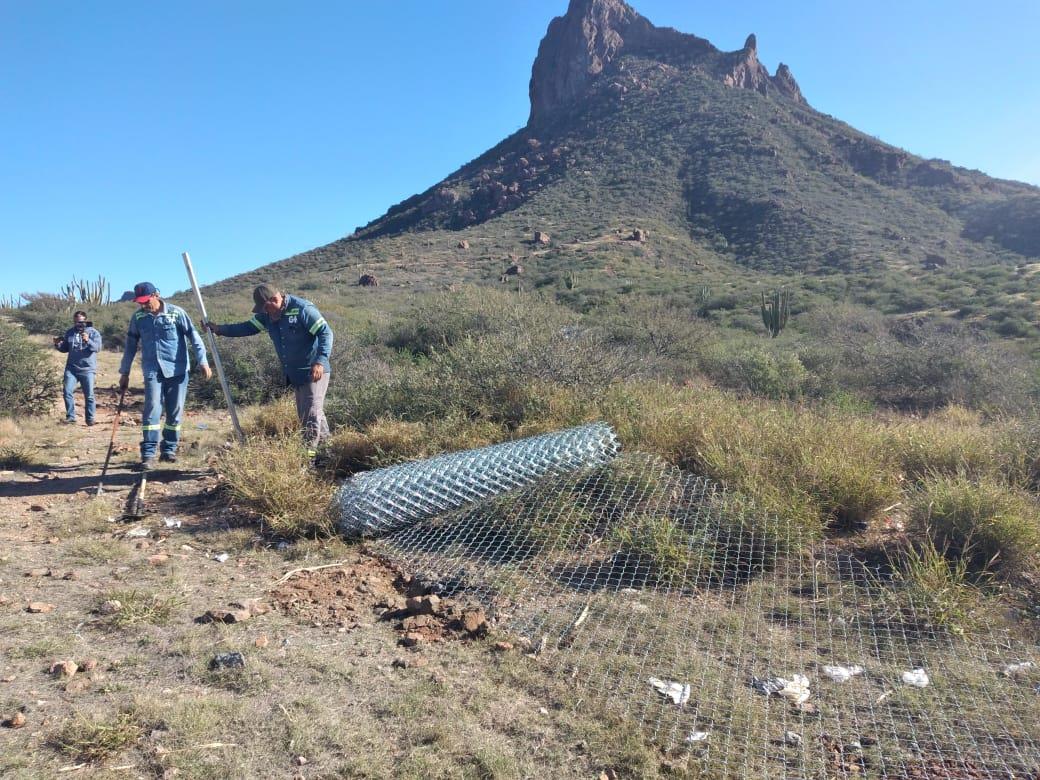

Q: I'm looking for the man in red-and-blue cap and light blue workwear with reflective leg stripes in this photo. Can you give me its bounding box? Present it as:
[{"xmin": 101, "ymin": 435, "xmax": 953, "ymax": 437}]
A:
[{"xmin": 120, "ymin": 282, "xmax": 213, "ymax": 471}]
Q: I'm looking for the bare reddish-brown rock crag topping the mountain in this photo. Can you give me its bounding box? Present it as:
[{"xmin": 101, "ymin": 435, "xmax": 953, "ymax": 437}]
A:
[{"xmin": 528, "ymin": 0, "xmax": 805, "ymax": 125}]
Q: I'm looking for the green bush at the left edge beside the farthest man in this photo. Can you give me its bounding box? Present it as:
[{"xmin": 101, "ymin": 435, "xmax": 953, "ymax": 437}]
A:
[{"xmin": 0, "ymin": 328, "xmax": 59, "ymax": 416}]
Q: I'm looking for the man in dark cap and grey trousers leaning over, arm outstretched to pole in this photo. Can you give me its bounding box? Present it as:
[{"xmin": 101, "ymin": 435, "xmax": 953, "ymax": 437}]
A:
[{"xmin": 206, "ymin": 284, "xmax": 332, "ymax": 458}]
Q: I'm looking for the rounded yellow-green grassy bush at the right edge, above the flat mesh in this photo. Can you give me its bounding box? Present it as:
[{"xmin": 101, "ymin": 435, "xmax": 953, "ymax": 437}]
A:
[{"xmin": 909, "ymin": 474, "xmax": 1040, "ymax": 575}]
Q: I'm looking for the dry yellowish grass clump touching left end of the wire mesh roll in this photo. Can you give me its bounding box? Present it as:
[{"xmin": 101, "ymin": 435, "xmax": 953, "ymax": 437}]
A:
[{"xmin": 216, "ymin": 436, "xmax": 333, "ymax": 537}]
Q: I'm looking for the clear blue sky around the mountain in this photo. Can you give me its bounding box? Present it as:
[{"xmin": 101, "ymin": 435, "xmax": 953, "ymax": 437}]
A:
[{"xmin": 0, "ymin": 0, "xmax": 1040, "ymax": 294}]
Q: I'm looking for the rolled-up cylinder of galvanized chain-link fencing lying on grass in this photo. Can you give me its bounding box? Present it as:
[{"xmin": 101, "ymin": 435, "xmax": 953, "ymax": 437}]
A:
[{"xmin": 333, "ymin": 422, "xmax": 619, "ymax": 537}]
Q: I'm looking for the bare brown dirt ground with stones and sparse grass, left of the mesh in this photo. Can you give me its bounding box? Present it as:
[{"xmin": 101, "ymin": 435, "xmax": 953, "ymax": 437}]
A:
[{"xmin": 0, "ymin": 341, "xmax": 681, "ymax": 778}]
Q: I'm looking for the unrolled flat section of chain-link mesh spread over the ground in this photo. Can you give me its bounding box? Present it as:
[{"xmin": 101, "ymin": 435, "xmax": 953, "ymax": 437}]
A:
[{"xmin": 355, "ymin": 436, "xmax": 1040, "ymax": 778}]
